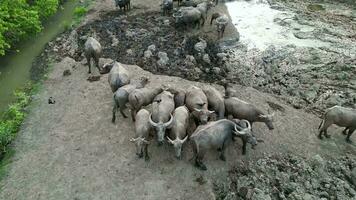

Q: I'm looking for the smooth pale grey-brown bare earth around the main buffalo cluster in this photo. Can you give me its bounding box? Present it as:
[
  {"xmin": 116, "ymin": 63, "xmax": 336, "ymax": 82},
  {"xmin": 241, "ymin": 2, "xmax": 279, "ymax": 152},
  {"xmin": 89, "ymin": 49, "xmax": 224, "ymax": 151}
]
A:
[{"xmin": 0, "ymin": 1, "xmax": 356, "ymax": 200}]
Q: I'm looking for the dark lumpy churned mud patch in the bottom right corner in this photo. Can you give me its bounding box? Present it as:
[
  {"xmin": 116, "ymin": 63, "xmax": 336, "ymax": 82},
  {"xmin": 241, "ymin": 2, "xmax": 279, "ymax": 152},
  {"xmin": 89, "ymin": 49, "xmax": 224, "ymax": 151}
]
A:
[{"xmin": 214, "ymin": 154, "xmax": 356, "ymax": 200}]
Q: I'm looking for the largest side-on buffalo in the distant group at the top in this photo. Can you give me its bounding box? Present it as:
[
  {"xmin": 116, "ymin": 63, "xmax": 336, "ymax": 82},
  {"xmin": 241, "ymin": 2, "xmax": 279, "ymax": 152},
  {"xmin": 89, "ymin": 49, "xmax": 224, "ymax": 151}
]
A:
[{"xmin": 173, "ymin": 7, "xmax": 205, "ymax": 28}]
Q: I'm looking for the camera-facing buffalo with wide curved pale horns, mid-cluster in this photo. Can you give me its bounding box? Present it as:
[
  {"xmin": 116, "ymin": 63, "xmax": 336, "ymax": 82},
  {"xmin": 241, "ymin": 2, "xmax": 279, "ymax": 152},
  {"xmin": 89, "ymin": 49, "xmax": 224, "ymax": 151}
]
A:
[{"xmin": 150, "ymin": 91, "xmax": 174, "ymax": 145}]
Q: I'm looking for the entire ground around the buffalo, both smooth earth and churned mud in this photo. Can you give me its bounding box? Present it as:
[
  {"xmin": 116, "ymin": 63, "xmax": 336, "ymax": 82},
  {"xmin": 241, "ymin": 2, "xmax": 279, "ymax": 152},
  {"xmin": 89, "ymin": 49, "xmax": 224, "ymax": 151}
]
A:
[{"xmin": 0, "ymin": 0, "xmax": 356, "ymax": 200}]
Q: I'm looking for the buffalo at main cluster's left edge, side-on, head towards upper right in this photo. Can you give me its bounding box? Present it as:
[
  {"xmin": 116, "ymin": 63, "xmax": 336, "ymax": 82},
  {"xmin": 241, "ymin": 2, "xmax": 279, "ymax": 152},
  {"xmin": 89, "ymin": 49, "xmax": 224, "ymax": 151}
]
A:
[{"xmin": 111, "ymin": 76, "xmax": 148, "ymax": 123}]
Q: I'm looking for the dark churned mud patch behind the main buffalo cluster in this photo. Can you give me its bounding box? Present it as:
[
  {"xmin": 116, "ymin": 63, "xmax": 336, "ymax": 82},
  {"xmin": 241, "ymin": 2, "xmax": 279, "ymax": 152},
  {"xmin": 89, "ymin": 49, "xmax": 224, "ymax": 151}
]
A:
[{"xmin": 76, "ymin": 12, "xmax": 226, "ymax": 82}]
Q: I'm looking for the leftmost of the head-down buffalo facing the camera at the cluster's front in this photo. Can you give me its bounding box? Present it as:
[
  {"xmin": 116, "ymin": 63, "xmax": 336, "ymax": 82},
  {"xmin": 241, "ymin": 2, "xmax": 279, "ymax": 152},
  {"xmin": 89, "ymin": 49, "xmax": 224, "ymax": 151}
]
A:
[{"xmin": 130, "ymin": 109, "xmax": 152, "ymax": 161}]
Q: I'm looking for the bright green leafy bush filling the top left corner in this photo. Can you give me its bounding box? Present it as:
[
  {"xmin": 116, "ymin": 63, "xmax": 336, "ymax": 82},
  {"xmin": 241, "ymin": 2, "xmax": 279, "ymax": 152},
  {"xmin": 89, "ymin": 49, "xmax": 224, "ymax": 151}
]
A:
[{"xmin": 0, "ymin": 0, "xmax": 59, "ymax": 55}]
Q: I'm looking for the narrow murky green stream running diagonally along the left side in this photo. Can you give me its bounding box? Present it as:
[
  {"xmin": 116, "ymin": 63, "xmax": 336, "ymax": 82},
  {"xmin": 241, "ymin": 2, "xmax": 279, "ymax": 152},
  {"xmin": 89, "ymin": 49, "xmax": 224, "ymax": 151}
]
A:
[{"xmin": 0, "ymin": 0, "xmax": 78, "ymax": 113}]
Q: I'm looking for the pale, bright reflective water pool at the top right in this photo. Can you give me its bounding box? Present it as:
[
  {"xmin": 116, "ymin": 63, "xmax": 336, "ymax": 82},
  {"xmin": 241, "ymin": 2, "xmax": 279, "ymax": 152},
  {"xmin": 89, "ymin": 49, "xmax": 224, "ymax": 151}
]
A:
[{"xmin": 226, "ymin": 0, "xmax": 328, "ymax": 50}]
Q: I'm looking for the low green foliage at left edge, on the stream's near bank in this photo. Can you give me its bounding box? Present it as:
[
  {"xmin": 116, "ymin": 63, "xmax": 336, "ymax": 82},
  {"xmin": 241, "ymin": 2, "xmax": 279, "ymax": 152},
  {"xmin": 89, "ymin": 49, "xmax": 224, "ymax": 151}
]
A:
[{"xmin": 0, "ymin": 85, "xmax": 33, "ymax": 154}]
